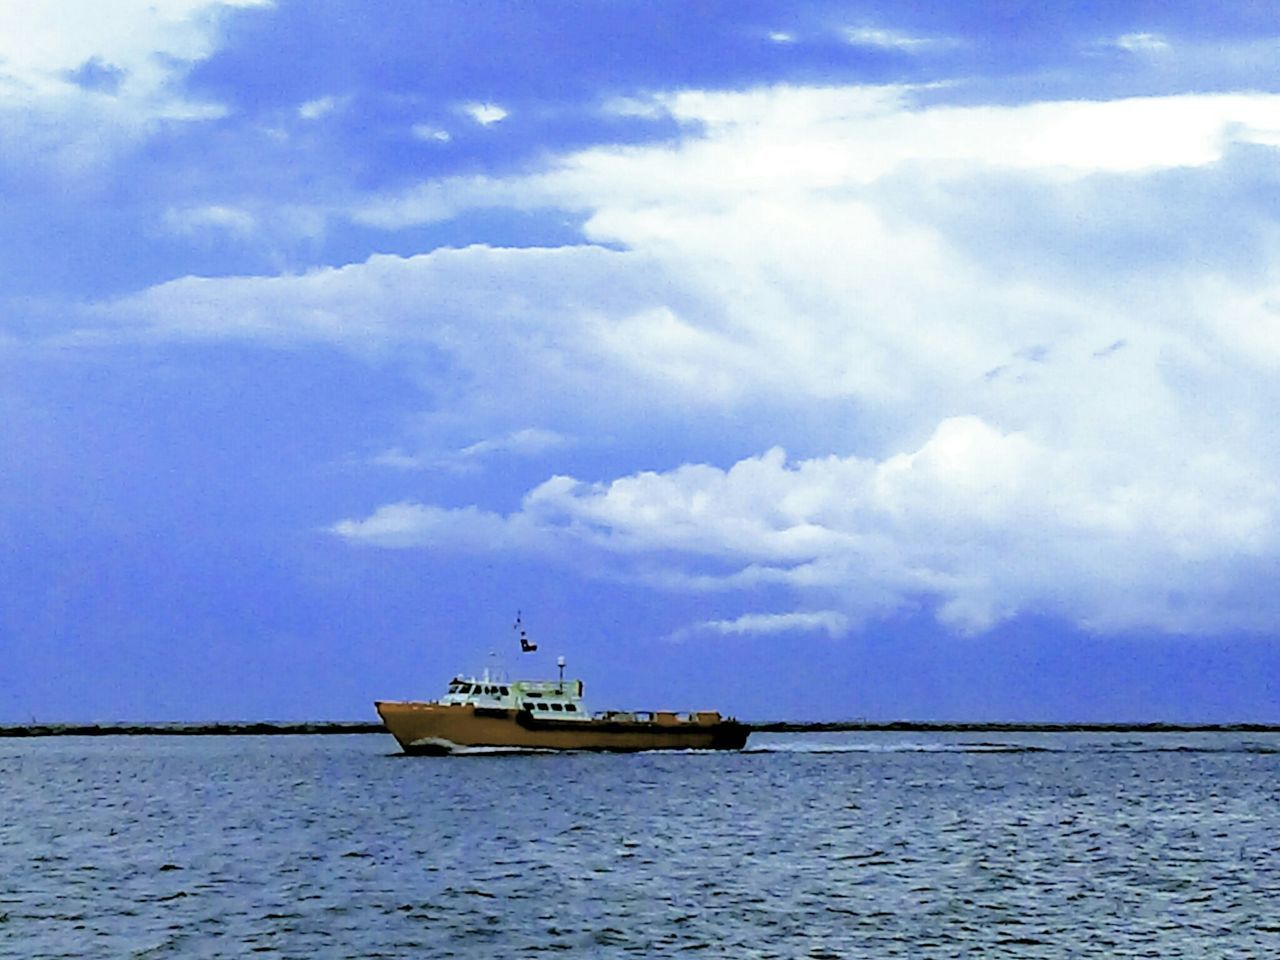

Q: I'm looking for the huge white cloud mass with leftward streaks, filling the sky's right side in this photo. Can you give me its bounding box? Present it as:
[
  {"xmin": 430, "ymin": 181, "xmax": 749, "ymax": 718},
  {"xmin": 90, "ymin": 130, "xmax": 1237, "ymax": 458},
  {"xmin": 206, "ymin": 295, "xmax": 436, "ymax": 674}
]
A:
[{"xmin": 82, "ymin": 87, "xmax": 1280, "ymax": 640}]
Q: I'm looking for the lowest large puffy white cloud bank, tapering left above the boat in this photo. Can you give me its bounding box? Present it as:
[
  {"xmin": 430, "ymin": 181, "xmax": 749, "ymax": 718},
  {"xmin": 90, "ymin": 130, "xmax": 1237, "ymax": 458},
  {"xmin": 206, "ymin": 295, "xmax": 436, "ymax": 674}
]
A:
[{"xmin": 334, "ymin": 417, "xmax": 1280, "ymax": 634}]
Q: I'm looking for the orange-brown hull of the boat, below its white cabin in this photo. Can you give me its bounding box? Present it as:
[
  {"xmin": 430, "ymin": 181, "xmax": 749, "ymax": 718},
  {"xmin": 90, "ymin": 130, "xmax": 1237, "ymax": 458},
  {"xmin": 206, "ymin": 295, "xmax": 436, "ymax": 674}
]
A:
[{"xmin": 374, "ymin": 700, "xmax": 750, "ymax": 755}]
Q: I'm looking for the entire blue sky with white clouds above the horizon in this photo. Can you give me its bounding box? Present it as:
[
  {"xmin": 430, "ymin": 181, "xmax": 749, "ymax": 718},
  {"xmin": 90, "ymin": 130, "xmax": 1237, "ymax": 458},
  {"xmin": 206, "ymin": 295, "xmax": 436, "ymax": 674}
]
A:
[{"xmin": 0, "ymin": 0, "xmax": 1280, "ymax": 722}]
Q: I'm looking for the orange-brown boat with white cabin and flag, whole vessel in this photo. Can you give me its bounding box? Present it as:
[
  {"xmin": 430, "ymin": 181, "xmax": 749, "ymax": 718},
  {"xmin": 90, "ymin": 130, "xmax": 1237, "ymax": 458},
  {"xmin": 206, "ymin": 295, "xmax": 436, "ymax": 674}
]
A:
[{"xmin": 374, "ymin": 627, "xmax": 750, "ymax": 755}]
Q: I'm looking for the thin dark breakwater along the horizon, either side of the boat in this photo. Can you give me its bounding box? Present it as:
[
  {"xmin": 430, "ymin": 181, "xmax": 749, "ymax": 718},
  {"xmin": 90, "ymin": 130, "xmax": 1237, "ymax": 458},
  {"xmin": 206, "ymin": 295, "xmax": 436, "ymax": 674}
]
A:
[{"xmin": 0, "ymin": 721, "xmax": 1280, "ymax": 737}]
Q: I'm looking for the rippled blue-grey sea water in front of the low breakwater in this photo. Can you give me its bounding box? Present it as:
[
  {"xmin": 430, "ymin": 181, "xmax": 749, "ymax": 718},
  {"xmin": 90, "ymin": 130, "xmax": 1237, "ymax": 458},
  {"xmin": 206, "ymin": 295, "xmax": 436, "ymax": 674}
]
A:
[{"xmin": 0, "ymin": 732, "xmax": 1280, "ymax": 960}]
